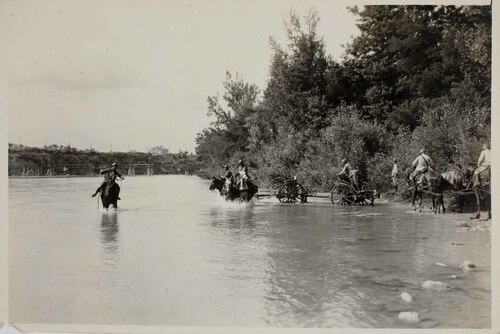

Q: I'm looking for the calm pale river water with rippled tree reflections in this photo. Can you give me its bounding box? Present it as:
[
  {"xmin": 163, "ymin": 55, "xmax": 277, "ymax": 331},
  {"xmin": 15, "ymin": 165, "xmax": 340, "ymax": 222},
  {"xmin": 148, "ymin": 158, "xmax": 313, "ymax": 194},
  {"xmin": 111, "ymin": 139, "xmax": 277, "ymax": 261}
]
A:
[{"xmin": 9, "ymin": 175, "xmax": 491, "ymax": 328}]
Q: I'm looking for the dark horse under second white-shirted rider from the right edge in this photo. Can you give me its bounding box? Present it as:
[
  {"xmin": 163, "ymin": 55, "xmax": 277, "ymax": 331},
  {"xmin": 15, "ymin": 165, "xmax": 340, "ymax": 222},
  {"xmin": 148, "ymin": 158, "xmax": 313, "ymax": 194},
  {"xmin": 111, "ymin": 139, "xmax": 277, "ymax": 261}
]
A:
[{"xmin": 406, "ymin": 168, "xmax": 446, "ymax": 213}]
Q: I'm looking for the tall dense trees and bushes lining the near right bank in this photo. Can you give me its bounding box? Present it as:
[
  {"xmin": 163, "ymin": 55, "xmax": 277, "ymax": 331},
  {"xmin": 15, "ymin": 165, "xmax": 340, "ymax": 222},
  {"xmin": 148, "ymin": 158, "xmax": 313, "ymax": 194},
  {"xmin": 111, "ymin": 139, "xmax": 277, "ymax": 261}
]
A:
[{"xmin": 196, "ymin": 6, "xmax": 491, "ymax": 191}]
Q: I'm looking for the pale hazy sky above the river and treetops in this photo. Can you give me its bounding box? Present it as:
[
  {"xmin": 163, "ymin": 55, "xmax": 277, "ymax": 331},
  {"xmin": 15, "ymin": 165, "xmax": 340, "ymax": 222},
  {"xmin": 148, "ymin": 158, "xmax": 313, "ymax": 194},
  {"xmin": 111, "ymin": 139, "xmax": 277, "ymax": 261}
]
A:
[{"xmin": 4, "ymin": 0, "xmax": 364, "ymax": 152}]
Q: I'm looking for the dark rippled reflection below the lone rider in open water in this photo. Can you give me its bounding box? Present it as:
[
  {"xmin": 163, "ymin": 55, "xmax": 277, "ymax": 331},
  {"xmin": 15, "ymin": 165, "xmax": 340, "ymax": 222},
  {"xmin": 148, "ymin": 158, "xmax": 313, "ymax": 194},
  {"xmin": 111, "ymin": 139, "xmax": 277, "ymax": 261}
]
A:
[{"xmin": 100, "ymin": 211, "xmax": 120, "ymax": 267}]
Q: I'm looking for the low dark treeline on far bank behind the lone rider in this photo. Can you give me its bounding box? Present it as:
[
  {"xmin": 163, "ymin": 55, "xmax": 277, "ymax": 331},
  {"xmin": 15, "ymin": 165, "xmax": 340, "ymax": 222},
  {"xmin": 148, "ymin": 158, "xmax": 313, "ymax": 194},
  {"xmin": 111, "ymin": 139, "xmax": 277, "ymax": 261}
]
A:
[{"xmin": 9, "ymin": 144, "xmax": 200, "ymax": 176}]
